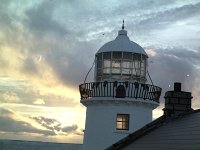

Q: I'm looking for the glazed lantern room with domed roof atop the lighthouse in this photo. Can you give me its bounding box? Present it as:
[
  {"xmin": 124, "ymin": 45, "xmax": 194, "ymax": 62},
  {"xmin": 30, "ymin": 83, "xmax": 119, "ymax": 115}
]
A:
[{"xmin": 95, "ymin": 26, "xmax": 148, "ymax": 83}]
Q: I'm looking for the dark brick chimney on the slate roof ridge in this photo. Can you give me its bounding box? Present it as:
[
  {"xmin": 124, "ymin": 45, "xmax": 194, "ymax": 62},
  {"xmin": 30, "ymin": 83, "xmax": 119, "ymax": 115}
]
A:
[{"xmin": 163, "ymin": 82, "xmax": 193, "ymax": 116}]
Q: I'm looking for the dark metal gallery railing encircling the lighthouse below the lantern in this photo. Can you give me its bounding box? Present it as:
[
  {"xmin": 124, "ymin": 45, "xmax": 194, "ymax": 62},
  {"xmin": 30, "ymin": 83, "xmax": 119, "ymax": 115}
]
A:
[{"xmin": 79, "ymin": 81, "xmax": 162, "ymax": 103}]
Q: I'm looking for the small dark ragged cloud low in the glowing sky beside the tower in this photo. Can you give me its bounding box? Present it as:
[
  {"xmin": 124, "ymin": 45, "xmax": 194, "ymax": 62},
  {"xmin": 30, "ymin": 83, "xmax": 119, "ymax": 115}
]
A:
[{"xmin": 31, "ymin": 116, "xmax": 78, "ymax": 133}]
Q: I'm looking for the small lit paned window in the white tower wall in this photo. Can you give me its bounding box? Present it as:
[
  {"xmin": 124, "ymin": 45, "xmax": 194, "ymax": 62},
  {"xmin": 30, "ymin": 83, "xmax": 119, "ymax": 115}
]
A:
[{"xmin": 116, "ymin": 114, "xmax": 130, "ymax": 130}]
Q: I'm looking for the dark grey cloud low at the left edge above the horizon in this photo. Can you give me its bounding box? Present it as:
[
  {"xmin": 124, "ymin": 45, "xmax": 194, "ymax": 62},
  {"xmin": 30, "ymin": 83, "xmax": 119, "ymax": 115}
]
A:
[{"xmin": 0, "ymin": 108, "xmax": 55, "ymax": 136}]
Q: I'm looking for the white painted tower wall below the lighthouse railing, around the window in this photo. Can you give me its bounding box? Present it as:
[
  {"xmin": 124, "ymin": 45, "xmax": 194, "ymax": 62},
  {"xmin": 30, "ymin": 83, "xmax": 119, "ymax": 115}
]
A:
[{"xmin": 82, "ymin": 98, "xmax": 157, "ymax": 150}]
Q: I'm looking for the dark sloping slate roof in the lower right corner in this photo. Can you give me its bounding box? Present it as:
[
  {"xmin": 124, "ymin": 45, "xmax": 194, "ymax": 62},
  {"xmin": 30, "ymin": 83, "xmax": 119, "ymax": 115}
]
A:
[{"xmin": 107, "ymin": 109, "xmax": 200, "ymax": 150}]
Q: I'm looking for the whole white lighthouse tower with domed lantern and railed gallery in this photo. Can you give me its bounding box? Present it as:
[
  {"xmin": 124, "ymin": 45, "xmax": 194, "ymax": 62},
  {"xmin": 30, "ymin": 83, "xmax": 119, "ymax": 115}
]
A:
[{"xmin": 79, "ymin": 23, "xmax": 161, "ymax": 150}]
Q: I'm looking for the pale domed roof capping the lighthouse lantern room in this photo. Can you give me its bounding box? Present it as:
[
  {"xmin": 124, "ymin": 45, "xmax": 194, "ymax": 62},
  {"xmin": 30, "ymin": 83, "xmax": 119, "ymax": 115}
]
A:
[{"xmin": 97, "ymin": 29, "xmax": 147, "ymax": 56}]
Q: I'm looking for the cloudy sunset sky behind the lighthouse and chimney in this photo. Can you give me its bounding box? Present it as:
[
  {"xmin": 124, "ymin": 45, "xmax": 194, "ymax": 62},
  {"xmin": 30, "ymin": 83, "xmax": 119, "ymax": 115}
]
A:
[{"xmin": 0, "ymin": 0, "xmax": 200, "ymax": 143}]
